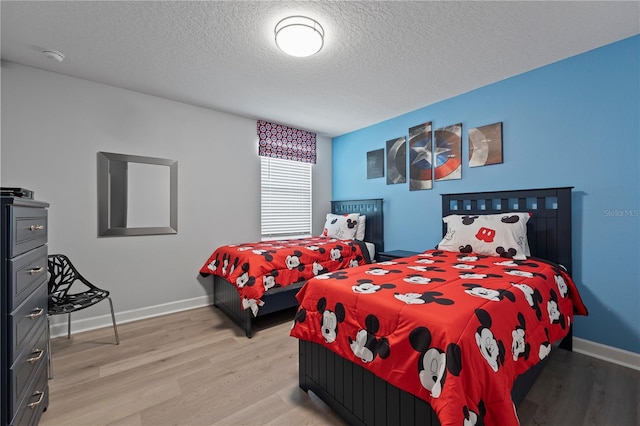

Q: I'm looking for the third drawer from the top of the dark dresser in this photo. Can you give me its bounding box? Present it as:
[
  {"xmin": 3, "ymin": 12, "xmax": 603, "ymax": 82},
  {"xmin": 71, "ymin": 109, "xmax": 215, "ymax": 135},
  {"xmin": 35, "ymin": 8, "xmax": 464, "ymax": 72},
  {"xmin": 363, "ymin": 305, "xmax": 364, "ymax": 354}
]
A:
[{"xmin": 9, "ymin": 283, "xmax": 47, "ymax": 359}]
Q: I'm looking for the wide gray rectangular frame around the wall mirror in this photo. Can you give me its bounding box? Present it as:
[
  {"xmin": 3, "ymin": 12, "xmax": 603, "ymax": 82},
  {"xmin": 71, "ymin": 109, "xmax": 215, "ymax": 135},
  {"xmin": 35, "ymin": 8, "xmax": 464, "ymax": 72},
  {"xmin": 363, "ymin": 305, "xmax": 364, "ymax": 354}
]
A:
[{"xmin": 98, "ymin": 152, "xmax": 178, "ymax": 236}]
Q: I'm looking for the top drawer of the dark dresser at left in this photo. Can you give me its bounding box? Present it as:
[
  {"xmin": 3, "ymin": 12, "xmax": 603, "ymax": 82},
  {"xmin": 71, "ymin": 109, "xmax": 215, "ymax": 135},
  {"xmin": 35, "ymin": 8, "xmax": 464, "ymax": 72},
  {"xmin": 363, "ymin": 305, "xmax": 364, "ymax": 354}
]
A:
[{"xmin": 9, "ymin": 206, "xmax": 49, "ymax": 257}]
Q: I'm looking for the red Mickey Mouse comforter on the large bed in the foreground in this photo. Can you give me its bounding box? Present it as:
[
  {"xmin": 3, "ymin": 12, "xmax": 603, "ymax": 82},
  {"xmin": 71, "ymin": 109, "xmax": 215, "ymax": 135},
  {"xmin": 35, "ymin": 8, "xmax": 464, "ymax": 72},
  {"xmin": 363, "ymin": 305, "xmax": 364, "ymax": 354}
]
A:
[{"xmin": 291, "ymin": 250, "xmax": 587, "ymax": 426}]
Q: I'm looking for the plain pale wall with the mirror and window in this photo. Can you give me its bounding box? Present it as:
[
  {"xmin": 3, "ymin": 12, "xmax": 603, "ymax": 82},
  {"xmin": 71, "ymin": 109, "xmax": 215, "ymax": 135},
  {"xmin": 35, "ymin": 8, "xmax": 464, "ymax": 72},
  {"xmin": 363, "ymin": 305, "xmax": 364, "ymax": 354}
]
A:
[{"xmin": 0, "ymin": 62, "xmax": 331, "ymax": 334}]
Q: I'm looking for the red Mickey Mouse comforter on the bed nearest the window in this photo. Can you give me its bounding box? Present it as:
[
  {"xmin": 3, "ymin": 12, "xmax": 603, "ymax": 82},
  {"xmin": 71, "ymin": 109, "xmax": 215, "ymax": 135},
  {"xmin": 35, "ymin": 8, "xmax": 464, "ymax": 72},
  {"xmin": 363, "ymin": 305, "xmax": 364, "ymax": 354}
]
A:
[{"xmin": 200, "ymin": 237, "xmax": 371, "ymax": 315}]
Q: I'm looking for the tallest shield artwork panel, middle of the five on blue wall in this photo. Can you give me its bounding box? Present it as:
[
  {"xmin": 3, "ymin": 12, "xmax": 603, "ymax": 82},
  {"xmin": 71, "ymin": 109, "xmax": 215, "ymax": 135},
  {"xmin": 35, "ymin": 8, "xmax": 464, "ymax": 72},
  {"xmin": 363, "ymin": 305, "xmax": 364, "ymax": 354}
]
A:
[{"xmin": 409, "ymin": 122, "xmax": 433, "ymax": 191}]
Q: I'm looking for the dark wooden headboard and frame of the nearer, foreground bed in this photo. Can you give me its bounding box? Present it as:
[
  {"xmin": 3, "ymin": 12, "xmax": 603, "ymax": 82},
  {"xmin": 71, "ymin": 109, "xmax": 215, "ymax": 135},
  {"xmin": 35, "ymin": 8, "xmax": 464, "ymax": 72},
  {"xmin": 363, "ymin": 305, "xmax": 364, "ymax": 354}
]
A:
[{"xmin": 299, "ymin": 187, "xmax": 572, "ymax": 426}]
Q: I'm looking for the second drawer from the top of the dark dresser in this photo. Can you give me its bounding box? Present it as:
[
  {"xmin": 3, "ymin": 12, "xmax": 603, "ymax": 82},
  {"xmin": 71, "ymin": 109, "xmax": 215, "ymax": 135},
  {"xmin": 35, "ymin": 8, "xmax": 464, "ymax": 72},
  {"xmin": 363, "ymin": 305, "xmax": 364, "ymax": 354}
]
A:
[{"xmin": 9, "ymin": 245, "xmax": 47, "ymax": 311}]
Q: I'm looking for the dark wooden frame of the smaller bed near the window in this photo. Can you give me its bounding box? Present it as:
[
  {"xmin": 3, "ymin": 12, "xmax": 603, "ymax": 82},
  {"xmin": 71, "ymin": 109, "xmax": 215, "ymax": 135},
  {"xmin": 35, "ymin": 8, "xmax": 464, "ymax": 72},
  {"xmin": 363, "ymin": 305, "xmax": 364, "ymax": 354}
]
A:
[{"xmin": 213, "ymin": 198, "xmax": 384, "ymax": 338}]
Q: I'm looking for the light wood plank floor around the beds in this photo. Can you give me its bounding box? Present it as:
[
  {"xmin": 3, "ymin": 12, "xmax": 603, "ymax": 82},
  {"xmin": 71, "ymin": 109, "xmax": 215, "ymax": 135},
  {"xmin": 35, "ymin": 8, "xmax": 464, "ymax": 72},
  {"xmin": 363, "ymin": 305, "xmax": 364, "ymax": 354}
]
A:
[{"xmin": 40, "ymin": 307, "xmax": 640, "ymax": 426}]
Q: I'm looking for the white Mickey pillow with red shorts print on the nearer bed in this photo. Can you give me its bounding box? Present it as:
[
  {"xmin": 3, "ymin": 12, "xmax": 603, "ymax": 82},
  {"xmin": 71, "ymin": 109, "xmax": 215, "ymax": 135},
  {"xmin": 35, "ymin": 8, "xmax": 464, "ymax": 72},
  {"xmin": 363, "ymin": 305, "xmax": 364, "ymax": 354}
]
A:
[{"xmin": 438, "ymin": 213, "xmax": 531, "ymax": 260}]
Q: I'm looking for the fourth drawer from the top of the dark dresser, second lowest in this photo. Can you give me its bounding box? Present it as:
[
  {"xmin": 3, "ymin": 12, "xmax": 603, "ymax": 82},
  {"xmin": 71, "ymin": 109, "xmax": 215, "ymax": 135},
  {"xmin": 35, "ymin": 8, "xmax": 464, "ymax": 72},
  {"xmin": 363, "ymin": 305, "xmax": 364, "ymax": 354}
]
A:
[{"xmin": 9, "ymin": 328, "xmax": 48, "ymax": 414}]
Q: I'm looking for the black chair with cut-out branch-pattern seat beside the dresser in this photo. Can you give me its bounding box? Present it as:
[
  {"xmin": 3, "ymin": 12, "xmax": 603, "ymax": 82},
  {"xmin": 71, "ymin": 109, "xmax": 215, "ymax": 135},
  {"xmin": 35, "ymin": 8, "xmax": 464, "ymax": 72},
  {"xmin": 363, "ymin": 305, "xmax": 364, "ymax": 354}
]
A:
[{"xmin": 47, "ymin": 254, "xmax": 120, "ymax": 378}]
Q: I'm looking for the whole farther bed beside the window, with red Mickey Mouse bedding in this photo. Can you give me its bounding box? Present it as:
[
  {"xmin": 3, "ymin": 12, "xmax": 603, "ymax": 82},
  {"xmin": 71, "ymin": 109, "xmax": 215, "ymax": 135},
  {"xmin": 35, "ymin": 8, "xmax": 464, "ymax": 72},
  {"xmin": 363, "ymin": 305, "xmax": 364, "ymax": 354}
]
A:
[{"xmin": 200, "ymin": 199, "xmax": 384, "ymax": 338}]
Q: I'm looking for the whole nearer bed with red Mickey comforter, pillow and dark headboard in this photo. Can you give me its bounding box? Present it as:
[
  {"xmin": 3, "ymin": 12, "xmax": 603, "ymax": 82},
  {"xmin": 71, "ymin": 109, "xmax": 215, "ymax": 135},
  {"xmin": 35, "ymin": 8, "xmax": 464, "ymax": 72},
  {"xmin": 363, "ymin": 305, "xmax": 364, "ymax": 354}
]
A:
[{"xmin": 291, "ymin": 188, "xmax": 587, "ymax": 425}]
